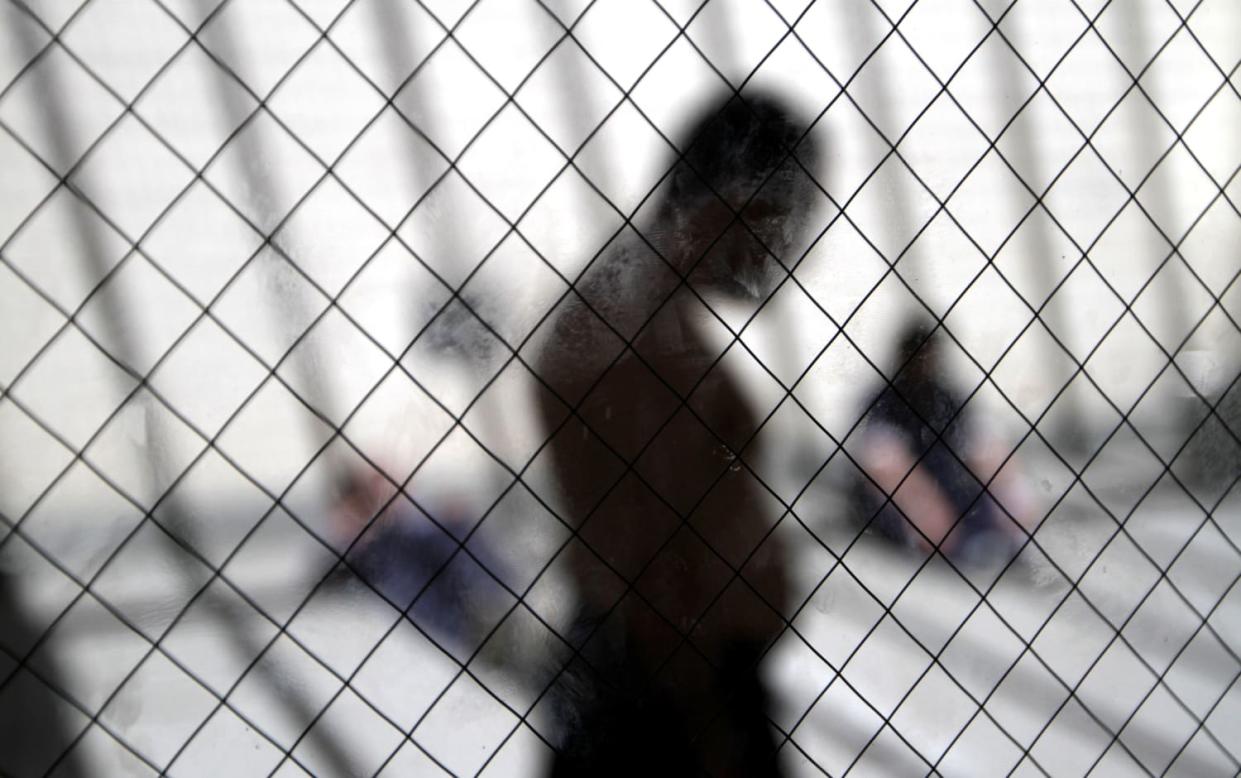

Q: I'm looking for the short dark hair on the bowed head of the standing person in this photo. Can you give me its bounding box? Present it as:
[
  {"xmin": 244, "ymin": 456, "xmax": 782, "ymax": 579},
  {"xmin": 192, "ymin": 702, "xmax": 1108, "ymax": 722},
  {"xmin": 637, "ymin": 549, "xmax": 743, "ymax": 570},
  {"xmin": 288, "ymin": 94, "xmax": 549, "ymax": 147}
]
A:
[{"xmin": 669, "ymin": 92, "xmax": 818, "ymax": 207}]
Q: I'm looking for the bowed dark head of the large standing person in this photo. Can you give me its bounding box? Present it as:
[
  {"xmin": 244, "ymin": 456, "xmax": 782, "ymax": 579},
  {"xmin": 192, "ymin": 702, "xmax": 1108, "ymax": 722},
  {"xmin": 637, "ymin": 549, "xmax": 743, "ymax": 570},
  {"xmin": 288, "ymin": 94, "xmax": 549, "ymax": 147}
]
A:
[{"xmin": 660, "ymin": 93, "xmax": 818, "ymax": 298}]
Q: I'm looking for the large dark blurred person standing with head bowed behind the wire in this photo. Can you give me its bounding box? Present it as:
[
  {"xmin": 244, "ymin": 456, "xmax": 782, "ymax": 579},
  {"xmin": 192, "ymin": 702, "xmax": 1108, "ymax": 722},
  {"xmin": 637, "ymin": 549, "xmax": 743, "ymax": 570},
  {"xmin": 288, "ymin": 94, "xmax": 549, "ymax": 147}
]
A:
[{"xmin": 536, "ymin": 94, "xmax": 815, "ymax": 776}]
